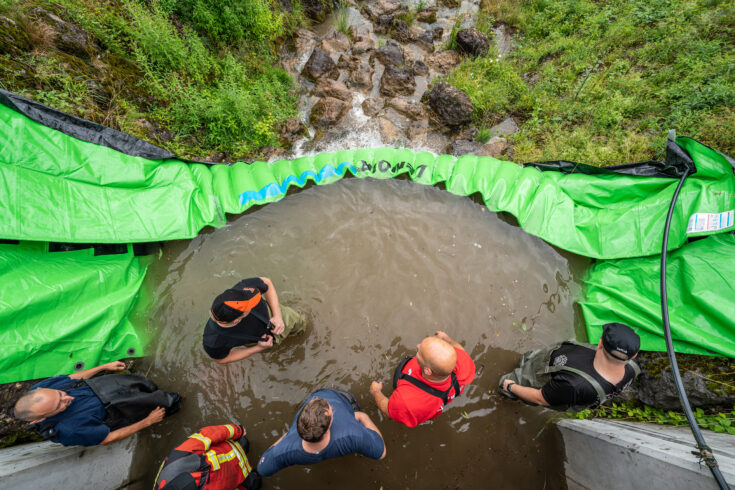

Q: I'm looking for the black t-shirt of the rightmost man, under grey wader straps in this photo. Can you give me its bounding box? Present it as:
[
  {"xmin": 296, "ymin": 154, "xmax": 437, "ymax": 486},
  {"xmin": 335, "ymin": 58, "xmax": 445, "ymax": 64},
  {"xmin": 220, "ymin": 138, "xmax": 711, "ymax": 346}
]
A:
[{"xmin": 541, "ymin": 343, "xmax": 635, "ymax": 411}]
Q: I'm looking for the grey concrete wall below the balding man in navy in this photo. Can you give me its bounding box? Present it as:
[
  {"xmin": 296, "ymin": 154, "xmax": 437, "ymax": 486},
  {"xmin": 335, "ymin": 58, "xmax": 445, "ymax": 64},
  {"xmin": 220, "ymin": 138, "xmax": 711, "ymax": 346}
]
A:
[{"xmin": 0, "ymin": 437, "xmax": 136, "ymax": 490}]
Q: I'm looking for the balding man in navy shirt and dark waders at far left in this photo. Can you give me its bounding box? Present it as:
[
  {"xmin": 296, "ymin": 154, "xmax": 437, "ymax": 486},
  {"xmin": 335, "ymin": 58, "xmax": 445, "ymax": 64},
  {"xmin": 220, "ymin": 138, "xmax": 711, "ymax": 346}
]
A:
[{"xmin": 14, "ymin": 361, "xmax": 180, "ymax": 446}]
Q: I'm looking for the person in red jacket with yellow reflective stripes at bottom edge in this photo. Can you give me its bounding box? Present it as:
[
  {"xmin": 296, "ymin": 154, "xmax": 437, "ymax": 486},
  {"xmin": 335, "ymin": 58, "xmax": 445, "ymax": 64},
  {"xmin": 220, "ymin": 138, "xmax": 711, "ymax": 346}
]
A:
[{"xmin": 154, "ymin": 424, "xmax": 261, "ymax": 490}]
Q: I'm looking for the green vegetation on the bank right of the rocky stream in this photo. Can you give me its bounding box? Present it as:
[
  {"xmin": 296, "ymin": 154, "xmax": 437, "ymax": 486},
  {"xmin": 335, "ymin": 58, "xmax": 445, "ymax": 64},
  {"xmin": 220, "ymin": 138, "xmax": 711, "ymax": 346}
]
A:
[{"xmin": 449, "ymin": 0, "xmax": 735, "ymax": 165}]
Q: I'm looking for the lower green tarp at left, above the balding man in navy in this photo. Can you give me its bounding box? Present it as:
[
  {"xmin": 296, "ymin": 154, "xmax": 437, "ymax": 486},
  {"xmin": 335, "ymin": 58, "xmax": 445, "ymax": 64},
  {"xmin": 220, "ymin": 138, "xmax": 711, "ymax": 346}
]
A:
[{"xmin": 0, "ymin": 242, "xmax": 146, "ymax": 383}]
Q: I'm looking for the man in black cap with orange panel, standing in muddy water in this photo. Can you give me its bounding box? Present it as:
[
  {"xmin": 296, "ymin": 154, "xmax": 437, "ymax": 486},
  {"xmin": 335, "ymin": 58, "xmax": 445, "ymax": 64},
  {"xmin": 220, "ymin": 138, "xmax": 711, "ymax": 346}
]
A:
[{"xmin": 203, "ymin": 277, "xmax": 306, "ymax": 364}]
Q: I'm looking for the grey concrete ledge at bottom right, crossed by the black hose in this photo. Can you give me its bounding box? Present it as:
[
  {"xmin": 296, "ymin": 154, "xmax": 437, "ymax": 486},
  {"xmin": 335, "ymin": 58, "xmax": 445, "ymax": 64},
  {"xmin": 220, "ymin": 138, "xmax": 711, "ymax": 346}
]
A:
[{"xmin": 557, "ymin": 419, "xmax": 735, "ymax": 490}]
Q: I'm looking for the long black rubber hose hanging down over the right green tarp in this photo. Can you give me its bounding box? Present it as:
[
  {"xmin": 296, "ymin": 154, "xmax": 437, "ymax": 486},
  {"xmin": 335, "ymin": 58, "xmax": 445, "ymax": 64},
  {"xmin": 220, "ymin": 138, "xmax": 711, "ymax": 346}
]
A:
[{"xmin": 661, "ymin": 168, "xmax": 730, "ymax": 490}]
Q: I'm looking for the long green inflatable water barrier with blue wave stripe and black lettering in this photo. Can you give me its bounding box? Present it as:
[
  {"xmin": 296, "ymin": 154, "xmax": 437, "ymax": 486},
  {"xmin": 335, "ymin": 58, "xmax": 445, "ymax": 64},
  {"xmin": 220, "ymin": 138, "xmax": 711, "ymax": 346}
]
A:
[{"xmin": 0, "ymin": 91, "xmax": 735, "ymax": 382}]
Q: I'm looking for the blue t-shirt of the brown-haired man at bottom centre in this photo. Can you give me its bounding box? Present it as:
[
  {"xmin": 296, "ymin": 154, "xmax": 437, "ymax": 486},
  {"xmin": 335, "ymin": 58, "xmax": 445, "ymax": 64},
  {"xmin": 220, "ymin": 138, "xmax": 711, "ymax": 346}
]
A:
[{"xmin": 258, "ymin": 390, "xmax": 385, "ymax": 476}]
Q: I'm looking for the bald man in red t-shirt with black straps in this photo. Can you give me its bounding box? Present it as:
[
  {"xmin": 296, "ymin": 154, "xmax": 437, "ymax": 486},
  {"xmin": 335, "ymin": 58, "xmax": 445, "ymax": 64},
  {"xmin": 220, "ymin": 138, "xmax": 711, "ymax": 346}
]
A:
[{"xmin": 370, "ymin": 331, "xmax": 475, "ymax": 427}]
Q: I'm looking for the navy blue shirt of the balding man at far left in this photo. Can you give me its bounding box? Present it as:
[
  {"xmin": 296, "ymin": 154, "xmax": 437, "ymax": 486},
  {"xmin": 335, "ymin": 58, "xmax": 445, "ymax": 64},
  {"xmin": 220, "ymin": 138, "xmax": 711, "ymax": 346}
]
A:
[{"xmin": 31, "ymin": 376, "xmax": 110, "ymax": 446}]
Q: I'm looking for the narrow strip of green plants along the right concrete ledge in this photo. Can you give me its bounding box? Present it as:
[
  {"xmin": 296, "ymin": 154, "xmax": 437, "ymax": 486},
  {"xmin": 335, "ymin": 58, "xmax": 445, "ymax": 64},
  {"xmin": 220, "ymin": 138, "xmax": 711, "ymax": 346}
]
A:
[{"xmin": 569, "ymin": 402, "xmax": 735, "ymax": 435}]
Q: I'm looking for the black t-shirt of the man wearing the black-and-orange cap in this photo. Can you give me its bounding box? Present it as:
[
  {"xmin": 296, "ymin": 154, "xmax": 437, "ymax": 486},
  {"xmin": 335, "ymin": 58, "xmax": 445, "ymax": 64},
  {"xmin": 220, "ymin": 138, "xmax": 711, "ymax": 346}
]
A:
[{"xmin": 202, "ymin": 277, "xmax": 270, "ymax": 359}]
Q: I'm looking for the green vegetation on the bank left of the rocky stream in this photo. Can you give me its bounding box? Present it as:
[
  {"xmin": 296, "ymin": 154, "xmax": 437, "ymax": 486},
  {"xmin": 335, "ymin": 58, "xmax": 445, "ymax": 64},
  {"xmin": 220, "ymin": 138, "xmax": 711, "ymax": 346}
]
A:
[{"xmin": 0, "ymin": 0, "xmax": 304, "ymax": 159}]
